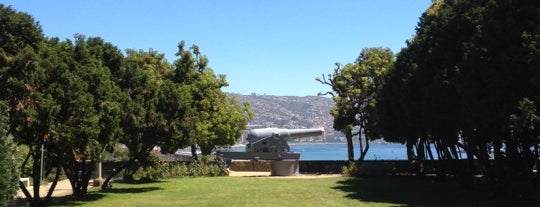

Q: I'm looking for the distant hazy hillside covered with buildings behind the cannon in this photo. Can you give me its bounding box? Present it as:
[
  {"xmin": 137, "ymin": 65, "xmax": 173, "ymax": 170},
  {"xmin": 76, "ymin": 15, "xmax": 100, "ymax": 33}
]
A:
[{"xmin": 229, "ymin": 94, "xmax": 341, "ymax": 142}]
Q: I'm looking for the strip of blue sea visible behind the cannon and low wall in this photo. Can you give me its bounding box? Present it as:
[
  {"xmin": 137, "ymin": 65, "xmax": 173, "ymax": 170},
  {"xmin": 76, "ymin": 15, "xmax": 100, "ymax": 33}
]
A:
[{"xmin": 231, "ymin": 143, "xmax": 407, "ymax": 160}]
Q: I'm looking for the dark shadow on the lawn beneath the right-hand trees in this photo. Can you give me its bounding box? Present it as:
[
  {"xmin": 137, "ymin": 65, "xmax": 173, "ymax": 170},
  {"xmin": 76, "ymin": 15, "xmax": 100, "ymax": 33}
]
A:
[{"xmin": 334, "ymin": 177, "xmax": 515, "ymax": 206}]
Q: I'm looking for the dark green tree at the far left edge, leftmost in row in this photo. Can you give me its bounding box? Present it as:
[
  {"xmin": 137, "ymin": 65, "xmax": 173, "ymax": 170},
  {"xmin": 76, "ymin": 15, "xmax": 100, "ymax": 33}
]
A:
[{"xmin": 0, "ymin": 5, "xmax": 54, "ymax": 206}]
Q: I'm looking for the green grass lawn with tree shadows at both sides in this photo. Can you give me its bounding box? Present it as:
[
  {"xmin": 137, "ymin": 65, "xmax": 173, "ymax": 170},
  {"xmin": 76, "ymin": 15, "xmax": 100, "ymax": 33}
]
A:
[{"xmin": 49, "ymin": 177, "xmax": 516, "ymax": 207}]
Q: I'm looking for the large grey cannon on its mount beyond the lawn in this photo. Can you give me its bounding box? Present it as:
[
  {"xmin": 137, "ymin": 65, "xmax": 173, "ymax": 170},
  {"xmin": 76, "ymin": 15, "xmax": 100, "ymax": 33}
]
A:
[{"xmin": 219, "ymin": 128, "xmax": 324, "ymax": 176}]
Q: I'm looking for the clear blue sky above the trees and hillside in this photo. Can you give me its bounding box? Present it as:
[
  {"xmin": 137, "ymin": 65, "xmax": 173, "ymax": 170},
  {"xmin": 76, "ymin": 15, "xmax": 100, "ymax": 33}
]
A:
[{"xmin": 0, "ymin": 0, "xmax": 431, "ymax": 96}]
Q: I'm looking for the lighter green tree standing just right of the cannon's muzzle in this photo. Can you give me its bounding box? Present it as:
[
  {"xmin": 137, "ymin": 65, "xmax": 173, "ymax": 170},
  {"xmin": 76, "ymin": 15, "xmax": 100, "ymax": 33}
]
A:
[{"xmin": 317, "ymin": 48, "xmax": 394, "ymax": 161}]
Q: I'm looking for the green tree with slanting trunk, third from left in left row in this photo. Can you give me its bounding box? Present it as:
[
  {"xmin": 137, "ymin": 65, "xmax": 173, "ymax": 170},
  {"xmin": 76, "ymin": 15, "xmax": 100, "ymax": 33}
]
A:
[{"xmin": 104, "ymin": 50, "xmax": 183, "ymax": 186}]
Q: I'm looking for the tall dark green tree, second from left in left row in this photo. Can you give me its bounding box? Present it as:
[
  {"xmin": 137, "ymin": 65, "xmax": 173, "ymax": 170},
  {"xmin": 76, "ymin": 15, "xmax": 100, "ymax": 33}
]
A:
[{"xmin": 48, "ymin": 36, "xmax": 122, "ymax": 195}]
